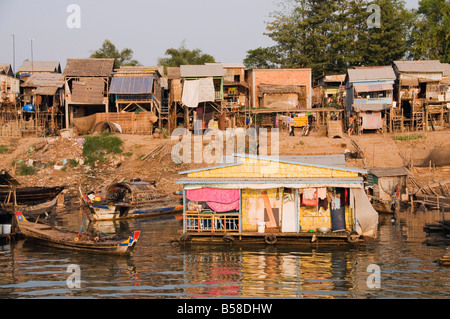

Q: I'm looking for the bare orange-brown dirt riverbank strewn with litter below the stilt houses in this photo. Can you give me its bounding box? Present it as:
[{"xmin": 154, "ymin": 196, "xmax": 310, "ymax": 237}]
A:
[{"xmin": 0, "ymin": 130, "xmax": 450, "ymax": 199}]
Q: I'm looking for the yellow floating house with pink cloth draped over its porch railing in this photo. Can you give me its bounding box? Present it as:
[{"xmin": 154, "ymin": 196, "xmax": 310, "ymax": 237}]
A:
[{"xmin": 177, "ymin": 155, "xmax": 378, "ymax": 244}]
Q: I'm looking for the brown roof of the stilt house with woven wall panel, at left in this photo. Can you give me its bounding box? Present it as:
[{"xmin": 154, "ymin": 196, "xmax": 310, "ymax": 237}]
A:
[{"xmin": 64, "ymin": 59, "xmax": 114, "ymax": 77}]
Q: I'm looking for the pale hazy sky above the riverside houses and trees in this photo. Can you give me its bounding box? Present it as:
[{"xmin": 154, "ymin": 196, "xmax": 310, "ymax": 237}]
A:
[{"xmin": 0, "ymin": 0, "xmax": 419, "ymax": 71}]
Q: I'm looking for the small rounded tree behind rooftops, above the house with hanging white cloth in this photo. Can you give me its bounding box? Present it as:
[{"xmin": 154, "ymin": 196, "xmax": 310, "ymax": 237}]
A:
[{"xmin": 158, "ymin": 41, "xmax": 216, "ymax": 67}]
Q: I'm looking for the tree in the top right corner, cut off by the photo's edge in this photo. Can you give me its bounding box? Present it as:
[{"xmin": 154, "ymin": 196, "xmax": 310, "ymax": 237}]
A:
[{"xmin": 412, "ymin": 0, "xmax": 450, "ymax": 63}]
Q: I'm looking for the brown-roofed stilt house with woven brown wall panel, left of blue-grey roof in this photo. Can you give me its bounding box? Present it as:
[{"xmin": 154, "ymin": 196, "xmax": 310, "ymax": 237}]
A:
[{"xmin": 64, "ymin": 59, "xmax": 114, "ymax": 128}]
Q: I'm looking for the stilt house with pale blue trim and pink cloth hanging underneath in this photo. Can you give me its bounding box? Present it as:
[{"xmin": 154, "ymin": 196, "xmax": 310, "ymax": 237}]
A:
[{"xmin": 345, "ymin": 66, "xmax": 396, "ymax": 133}]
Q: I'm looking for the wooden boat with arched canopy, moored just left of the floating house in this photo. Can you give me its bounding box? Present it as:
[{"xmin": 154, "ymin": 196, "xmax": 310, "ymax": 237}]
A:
[{"xmin": 80, "ymin": 181, "xmax": 183, "ymax": 221}]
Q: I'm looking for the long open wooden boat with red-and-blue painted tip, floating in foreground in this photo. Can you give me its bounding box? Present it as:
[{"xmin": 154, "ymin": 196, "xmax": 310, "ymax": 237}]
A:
[{"xmin": 15, "ymin": 211, "xmax": 140, "ymax": 255}]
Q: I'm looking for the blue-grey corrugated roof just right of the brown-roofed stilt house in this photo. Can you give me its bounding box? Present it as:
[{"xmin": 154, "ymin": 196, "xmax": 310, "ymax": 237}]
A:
[{"xmin": 109, "ymin": 76, "xmax": 153, "ymax": 94}]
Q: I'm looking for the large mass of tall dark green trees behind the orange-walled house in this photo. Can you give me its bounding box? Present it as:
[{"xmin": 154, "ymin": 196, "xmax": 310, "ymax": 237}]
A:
[{"xmin": 244, "ymin": 0, "xmax": 412, "ymax": 78}]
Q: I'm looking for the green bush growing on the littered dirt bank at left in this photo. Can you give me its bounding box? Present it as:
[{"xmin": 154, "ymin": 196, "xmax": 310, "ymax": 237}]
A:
[{"xmin": 83, "ymin": 133, "xmax": 123, "ymax": 165}]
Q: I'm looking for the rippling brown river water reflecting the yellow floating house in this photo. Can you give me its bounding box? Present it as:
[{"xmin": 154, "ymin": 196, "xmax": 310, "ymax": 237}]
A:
[{"xmin": 0, "ymin": 205, "xmax": 450, "ymax": 299}]
